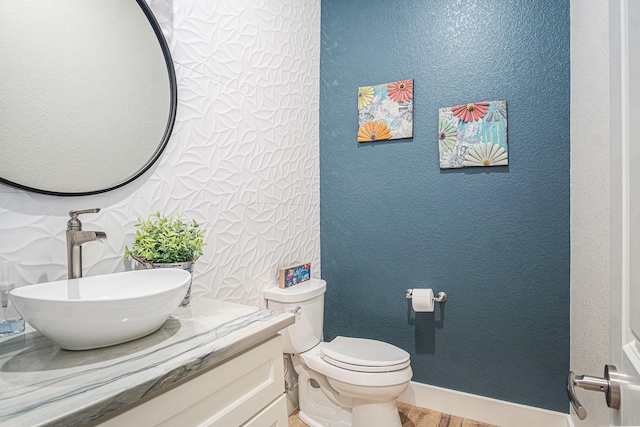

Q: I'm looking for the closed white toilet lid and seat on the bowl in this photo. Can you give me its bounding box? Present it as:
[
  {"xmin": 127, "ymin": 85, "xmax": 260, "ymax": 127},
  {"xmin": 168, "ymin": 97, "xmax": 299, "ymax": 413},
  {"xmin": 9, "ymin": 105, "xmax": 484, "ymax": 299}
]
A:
[{"xmin": 322, "ymin": 337, "xmax": 410, "ymax": 372}]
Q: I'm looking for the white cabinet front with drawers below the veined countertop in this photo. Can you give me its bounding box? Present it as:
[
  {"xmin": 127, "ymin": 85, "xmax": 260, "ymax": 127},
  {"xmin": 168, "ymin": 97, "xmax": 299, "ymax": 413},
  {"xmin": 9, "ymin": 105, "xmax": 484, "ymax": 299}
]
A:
[{"xmin": 98, "ymin": 335, "xmax": 287, "ymax": 427}]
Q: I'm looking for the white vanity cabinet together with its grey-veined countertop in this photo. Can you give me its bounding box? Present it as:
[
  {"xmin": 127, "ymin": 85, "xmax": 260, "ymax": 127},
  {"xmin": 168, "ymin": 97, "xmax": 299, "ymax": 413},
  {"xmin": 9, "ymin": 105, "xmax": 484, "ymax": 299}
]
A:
[{"xmin": 0, "ymin": 298, "xmax": 295, "ymax": 427}]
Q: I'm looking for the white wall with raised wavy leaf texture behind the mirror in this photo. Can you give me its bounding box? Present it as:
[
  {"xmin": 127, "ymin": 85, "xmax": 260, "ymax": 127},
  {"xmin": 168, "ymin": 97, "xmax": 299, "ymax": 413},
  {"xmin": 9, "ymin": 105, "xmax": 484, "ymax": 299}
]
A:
[{"xmin": 0, "ymin": 0, "xmax": 320, "ymax": 305}]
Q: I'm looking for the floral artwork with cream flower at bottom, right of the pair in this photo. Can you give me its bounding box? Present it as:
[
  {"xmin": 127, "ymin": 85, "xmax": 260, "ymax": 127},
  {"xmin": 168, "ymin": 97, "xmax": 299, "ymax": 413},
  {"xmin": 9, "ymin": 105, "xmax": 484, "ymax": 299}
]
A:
[{"xmin": 438, "ymin": 100, "xmax": 509, "ymax": 169}]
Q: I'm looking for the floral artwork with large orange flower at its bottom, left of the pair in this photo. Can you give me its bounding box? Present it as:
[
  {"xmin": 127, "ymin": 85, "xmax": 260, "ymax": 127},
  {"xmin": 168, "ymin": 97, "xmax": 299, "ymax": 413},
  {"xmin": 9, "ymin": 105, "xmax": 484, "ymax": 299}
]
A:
[{"xmin": 358, "ymin": 79, "xmax": 413, "ymax": 142}]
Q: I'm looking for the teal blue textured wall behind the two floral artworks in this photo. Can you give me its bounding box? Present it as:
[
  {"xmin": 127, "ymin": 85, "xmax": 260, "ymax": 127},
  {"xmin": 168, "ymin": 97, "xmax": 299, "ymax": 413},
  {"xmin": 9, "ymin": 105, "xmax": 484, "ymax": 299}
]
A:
[{"xmin": 320, "ymin": 0, "xmax": 568, "ymax": 412}]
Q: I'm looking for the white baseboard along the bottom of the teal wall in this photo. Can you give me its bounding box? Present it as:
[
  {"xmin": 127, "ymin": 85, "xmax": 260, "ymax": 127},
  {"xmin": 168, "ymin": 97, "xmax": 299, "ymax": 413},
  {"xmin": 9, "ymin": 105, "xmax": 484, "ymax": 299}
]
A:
[{"xmin": 398, "ymin": 381, "xmax": 573, "ymax": 427}]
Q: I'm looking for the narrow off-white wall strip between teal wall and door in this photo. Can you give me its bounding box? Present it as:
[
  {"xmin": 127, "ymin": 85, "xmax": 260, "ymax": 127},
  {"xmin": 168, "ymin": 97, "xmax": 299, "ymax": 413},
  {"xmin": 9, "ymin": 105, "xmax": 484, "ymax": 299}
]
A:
[{"xmin": 571, "ymin": 0, "xmax": 610, "ymax": 426}]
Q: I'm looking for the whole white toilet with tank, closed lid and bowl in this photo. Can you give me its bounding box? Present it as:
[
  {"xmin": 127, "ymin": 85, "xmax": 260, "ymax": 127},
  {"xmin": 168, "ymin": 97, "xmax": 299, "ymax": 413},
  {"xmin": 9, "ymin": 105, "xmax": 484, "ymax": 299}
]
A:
[{"xmin": 264, "ymin": 279, "xmax": 413, "ymax": 427}]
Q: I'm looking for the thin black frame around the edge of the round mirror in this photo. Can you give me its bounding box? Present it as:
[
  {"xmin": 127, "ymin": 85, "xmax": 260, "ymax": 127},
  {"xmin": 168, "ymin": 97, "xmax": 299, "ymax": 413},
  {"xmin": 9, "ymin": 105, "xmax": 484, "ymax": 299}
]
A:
[{"xmin": 0, "ymin": 0, "xmax": 178, "ymax": 197}]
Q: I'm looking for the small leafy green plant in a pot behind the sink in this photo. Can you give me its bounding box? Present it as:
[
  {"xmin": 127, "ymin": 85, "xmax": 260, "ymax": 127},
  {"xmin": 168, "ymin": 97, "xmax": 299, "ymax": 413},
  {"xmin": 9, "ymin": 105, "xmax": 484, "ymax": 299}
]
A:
[{"xmin": 124, "ymin": 211, "xmax": 205, "ymax": 306}]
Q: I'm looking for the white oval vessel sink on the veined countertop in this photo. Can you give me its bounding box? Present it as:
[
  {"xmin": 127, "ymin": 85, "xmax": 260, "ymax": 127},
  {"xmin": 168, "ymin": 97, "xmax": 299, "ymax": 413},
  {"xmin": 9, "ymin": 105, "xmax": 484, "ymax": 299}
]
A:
[{"xmin": 11, "ymin": 268, "xmax": 191, "ymax": 350}]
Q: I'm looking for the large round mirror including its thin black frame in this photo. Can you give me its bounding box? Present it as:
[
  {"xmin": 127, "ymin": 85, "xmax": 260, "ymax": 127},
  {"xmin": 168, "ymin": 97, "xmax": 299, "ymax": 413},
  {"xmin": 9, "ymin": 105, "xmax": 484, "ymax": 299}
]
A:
[{"xmin": 0, "ymin": 0, "xmax": 177, "ymax": 196}]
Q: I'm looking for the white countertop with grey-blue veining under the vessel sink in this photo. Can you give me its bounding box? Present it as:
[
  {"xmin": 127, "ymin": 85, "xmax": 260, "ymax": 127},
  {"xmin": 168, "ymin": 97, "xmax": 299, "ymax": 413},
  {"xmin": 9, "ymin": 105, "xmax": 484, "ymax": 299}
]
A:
[{"xmin": 0, "ymin": 298, "xmax": 294, "ymax": 427}]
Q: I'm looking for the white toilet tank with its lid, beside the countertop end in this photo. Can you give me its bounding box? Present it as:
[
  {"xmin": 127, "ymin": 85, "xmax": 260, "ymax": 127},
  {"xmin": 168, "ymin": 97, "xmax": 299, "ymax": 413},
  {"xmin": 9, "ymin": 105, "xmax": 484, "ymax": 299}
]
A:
[{"xmin": 264, "ymin": 279, "xmax": 327, "ymax": 354}]
